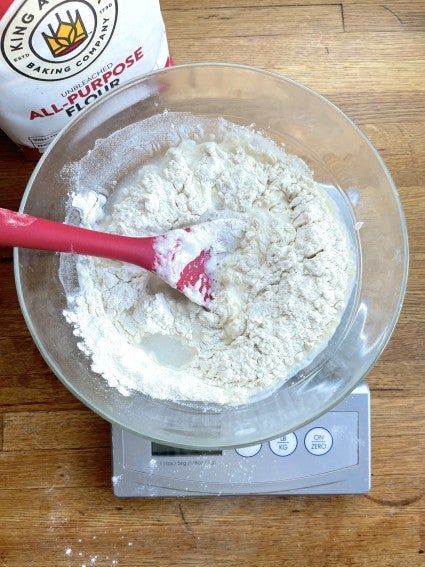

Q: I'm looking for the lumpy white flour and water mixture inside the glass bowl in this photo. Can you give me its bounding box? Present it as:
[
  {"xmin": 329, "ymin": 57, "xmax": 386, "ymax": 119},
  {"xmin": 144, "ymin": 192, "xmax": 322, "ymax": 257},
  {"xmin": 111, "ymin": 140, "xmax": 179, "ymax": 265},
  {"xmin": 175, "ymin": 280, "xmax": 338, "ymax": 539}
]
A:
[{"xmin": 65, "ymin": 115, "xmax": 355, "ymax": 405}]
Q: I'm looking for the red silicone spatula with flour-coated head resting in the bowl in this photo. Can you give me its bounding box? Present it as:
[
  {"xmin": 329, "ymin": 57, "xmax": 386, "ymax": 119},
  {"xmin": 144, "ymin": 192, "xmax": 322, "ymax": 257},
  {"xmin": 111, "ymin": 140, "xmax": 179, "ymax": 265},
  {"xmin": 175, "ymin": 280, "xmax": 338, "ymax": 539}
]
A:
[{"xmin": 0, "ymin": 208, "xmax": 244, "ymax": 307}]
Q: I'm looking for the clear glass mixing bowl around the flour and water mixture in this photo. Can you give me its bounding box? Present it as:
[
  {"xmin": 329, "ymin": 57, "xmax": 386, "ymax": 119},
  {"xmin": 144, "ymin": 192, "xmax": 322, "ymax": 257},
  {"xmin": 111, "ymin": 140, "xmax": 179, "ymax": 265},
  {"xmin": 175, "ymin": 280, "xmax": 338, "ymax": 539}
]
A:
[{"xmin": 15, "ymin": 64, "xmax": 408, "ymax": 449}]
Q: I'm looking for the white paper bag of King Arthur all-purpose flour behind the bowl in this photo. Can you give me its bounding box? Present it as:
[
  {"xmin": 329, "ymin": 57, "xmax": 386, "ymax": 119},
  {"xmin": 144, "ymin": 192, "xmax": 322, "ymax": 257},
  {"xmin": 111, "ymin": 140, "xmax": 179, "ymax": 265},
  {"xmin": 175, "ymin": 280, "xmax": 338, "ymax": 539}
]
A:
[{"xmin": 0, "ymin": 0, "xmax": 170, "ymax": 159}]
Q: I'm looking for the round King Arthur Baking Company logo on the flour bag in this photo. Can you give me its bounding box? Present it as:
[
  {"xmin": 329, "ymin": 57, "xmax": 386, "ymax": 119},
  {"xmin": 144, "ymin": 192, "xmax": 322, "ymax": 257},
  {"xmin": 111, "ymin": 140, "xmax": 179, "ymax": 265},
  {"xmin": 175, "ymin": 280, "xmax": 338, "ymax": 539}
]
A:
[{"xmin": 1, "ymin": 0, "xmax": 118, "ymax": 81}]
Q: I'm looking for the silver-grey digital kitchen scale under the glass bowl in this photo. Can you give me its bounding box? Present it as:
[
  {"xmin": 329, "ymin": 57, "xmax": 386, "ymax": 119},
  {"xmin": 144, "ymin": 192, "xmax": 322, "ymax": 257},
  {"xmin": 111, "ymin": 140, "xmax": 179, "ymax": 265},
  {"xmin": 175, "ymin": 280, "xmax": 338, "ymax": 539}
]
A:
[{"xmin": 112, "ymin": 383, "xmax": 371, "ymax": 497}]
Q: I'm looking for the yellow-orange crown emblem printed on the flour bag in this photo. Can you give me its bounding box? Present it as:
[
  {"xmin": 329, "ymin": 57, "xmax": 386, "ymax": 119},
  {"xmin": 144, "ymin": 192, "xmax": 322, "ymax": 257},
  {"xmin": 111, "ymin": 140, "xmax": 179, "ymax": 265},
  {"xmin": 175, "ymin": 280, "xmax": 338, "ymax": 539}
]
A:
[{"xmin": 42, "ymin": 10, "xmax": 88, "ymax": 57}]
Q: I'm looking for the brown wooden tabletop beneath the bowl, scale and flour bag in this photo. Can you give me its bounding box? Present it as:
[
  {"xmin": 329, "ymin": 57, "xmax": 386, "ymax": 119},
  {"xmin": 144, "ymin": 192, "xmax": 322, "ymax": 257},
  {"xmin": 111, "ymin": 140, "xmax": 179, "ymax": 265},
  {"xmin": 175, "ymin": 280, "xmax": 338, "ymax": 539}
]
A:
[{"xmin": 0, "ymin": 0, "xmax": 425, "ymax": 567}]
